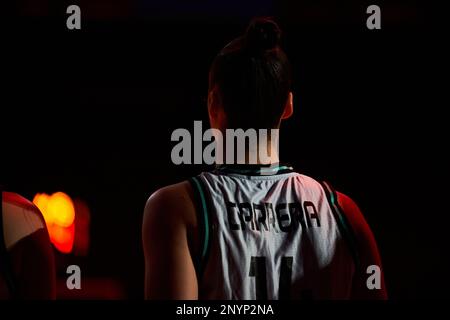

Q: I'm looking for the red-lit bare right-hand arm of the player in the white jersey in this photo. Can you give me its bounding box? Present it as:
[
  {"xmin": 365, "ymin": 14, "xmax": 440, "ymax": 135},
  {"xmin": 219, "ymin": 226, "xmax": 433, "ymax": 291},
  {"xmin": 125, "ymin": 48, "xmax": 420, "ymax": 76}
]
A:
[{"xmin": 337, "ymin": 192, "xmax": 387, "ymax": 299}]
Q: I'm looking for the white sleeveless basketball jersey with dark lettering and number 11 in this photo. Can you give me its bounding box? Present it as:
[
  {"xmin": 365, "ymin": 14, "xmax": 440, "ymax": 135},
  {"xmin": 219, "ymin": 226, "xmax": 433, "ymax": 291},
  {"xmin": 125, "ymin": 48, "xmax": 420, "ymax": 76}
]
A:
[{"xmin": 191, "ymin": 166, "xmax": 357, "ymax": 300}]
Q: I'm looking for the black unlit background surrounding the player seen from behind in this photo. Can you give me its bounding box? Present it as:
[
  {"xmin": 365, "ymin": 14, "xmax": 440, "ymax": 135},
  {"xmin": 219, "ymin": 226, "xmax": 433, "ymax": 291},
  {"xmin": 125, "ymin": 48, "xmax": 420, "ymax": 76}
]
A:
[{"xmin": 0, "ymin": 0, "xmax": 450, "ymax": 299}]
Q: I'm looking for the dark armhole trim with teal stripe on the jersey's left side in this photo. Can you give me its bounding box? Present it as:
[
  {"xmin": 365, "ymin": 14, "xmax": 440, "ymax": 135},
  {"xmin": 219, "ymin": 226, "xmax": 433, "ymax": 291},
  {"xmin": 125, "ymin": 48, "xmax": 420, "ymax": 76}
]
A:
[{"xmin": 189, "ymin": 177, "xmax": 211, "ymax": 281}]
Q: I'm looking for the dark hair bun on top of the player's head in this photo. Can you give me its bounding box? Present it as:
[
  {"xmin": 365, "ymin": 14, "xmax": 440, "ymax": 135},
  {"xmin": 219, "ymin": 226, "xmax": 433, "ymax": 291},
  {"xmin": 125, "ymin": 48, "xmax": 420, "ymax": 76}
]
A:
[{"xmin": 245, "ymin": 18, "xmax": 281, "ymax": 51}]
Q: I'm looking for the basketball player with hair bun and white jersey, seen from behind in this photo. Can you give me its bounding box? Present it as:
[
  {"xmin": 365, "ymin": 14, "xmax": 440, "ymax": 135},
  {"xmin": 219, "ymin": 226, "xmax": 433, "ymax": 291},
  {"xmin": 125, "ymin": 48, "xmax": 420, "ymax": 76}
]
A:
[{"xmin": 142, "ymin": 18, "xmax": 386, "ymax": 299}]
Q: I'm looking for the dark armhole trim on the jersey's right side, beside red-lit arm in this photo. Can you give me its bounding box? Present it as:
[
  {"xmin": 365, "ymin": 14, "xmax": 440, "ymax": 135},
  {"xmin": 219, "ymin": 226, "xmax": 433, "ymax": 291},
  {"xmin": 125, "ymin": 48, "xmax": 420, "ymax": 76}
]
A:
[{"xmin": 320, "ymin": 181, "xmax": 360, "ymax": 269}]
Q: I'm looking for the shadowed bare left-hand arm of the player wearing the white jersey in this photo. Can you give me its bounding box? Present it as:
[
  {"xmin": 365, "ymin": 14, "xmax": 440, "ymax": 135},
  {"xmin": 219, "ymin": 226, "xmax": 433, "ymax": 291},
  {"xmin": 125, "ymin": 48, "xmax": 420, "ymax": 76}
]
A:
[{"xmin": 142, "ymin": 182, "xmax": 198, "ymax": 300}]
